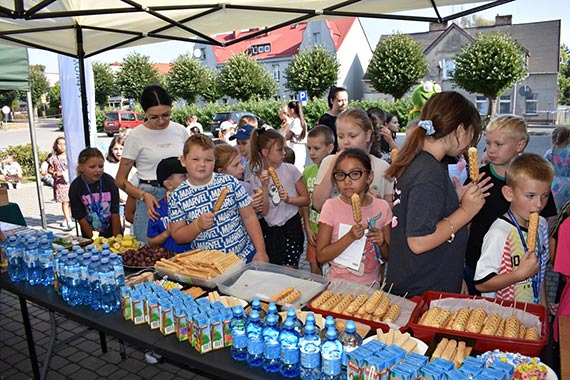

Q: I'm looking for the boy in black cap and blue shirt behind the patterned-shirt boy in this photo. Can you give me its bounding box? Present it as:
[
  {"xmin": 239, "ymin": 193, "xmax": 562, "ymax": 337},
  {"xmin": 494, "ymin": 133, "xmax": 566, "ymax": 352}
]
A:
[{"xmin": 146, "ymin": 157, "xmax": 190, "ymax": 253}]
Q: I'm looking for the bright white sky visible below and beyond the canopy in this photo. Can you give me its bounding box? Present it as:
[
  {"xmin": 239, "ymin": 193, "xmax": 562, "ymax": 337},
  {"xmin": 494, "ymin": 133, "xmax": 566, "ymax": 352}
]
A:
[{"xmin": 29, "ymin": 0, "xmax": 570, "ymax": 81}]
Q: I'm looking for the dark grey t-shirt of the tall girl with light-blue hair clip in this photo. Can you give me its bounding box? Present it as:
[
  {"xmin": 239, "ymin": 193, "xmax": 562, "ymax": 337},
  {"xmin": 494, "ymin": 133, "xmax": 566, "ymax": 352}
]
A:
[{"xmin": 386, "ymin": 151, "xmax": 467, "ymax": 297}]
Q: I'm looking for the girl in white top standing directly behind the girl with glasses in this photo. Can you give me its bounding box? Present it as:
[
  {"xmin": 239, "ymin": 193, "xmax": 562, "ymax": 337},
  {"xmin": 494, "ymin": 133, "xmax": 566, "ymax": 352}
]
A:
[{"xmin": 313, "ymin": 108, "xmax": 394, "ymax": 211}]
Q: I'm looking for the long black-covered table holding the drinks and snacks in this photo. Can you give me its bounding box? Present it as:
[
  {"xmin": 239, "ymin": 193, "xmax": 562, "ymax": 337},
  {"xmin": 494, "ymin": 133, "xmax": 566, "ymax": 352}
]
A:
[{"xmin": 0, "ymin": 272, "xmax": 283, "ymax": 380}]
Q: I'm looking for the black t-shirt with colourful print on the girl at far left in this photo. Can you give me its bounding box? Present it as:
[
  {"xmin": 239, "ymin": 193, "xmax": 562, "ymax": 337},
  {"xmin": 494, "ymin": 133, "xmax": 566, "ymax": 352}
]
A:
[{"xmin": 69, "ymin": 173, "xmax": 119, "ymax": 237}]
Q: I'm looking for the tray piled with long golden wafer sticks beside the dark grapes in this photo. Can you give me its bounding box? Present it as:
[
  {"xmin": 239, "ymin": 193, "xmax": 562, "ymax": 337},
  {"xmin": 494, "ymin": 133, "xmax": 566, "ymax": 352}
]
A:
[{"xmin": 154, "ymin": 249, "xmax": 245, "ymax": 288}]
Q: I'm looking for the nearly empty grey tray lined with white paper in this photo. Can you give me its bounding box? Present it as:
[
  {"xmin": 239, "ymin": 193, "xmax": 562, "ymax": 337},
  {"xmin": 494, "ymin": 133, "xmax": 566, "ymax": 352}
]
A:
[{"xmin": 217, "ymin": 261, "xmax": 329, "ymax": 309}]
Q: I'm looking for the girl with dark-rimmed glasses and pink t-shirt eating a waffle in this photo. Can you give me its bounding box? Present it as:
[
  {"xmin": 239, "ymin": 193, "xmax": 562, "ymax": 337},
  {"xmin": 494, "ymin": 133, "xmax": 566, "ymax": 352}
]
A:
[{"xmin": 317, "ymin": 148, "xmax": 392, "ymax": 285}]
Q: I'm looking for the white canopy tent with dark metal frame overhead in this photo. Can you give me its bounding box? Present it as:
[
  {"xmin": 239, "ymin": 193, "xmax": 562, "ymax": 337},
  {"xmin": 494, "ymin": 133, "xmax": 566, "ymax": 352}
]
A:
[{"xmin": 0, "ymin": 0, "xmax": 514, "ymax": 145}]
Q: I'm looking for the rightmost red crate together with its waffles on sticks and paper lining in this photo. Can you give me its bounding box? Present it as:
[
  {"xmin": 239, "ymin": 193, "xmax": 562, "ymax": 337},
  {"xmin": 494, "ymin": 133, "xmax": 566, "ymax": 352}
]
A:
[{"xmin": 410, "ymin": 291, "xmax": 548, "ymax": 356}]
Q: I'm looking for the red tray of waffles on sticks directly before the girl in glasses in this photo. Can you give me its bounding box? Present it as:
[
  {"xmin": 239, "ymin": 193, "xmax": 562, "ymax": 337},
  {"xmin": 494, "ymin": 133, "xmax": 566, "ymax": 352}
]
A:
[{"xmin": 308, "ymin": 280, "xmax": 420, "ymax": 331}]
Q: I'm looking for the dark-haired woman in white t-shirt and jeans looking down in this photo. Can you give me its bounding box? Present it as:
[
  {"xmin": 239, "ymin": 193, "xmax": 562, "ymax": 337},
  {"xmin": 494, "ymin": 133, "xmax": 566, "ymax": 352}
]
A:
[{"xmin": 115, "ymin": 86, "xmax": 188, "ymax": 242}]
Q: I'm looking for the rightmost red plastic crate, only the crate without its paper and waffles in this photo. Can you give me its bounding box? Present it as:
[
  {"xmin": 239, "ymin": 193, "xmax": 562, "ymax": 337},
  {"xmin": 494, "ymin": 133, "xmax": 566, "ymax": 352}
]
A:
[{"xmin": 408, "ymin": 291, "xmax": 549, "ymax": 356}]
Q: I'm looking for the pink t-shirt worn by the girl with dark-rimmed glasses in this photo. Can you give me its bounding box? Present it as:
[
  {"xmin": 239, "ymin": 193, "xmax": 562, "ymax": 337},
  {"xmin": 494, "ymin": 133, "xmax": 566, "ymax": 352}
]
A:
[{"xmin": 319, "ymin": 197, "xmax": 392, "ymax": 285}]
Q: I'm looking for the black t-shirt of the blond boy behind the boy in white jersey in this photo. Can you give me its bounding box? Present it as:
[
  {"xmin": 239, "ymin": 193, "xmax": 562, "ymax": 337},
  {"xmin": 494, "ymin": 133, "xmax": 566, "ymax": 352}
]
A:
[{"xmin": 465, "ymin": 164, "xmax": 556, "ymax": 270}]
